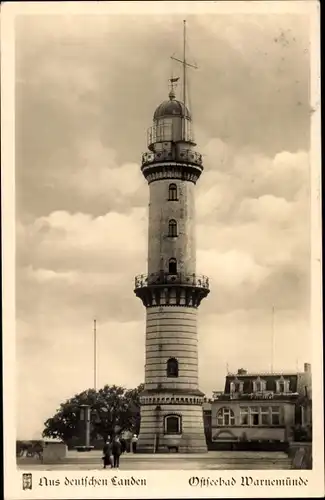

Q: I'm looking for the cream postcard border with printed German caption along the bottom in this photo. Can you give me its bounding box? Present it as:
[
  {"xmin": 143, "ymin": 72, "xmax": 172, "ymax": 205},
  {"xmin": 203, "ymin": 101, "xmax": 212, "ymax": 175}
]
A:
[{"xmin": 1, "ymin": 1, "xmax": 324, "ymax": 500}]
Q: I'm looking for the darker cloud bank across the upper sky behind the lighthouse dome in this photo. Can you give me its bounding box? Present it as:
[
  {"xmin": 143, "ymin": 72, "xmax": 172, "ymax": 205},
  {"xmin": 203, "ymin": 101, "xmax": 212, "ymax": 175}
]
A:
[{"xmin": 16, "ymin": 15, "xmax": 310, "ymax": 217}]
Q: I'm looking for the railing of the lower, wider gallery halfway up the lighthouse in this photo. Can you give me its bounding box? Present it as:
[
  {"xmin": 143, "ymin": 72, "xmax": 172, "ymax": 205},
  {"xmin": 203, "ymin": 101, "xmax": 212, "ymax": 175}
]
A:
[{"xmin": 135, "ymin": 272, "xmax": 209, "ymax": 290}]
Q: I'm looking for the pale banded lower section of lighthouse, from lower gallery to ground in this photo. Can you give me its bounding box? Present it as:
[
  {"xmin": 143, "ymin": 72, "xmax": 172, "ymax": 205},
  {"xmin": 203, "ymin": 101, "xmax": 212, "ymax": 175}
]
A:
[{"xmin": 138, "ymin": 304, "xmax": 207, "ymax": 453}]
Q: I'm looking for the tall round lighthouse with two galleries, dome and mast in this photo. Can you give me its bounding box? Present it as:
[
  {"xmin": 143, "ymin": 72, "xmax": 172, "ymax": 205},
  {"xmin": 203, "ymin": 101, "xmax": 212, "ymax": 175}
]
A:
[{"xmin": 134, "ymin": 21, "xmax": 209, "ymax": 453}]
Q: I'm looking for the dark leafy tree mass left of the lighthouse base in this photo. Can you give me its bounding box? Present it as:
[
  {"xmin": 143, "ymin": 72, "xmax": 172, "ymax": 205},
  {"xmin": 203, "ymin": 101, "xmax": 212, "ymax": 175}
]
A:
[{"xmin": 43, "ymin": 384, "xmax": 144, "ymax": 442}]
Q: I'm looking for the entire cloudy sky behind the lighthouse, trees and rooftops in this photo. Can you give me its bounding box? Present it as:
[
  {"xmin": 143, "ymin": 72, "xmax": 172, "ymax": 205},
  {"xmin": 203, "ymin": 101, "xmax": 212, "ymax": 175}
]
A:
[{"xmin": 16, "ymin": 5, "xmax": 311, "ymax": 438}]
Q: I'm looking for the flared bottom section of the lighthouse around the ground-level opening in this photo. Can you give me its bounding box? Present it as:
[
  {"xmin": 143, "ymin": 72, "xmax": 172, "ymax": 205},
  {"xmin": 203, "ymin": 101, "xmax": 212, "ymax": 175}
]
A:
[{"xmin": 137, "ymin": 402, "xmax": 207, "ymax": 453}]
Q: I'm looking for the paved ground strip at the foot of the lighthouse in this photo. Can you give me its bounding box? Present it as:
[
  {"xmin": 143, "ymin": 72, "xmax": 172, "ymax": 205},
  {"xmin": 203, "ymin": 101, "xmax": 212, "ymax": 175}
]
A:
[{"xmin": 17, "ymin": 451, "xmax": 291, "ymax": 474}]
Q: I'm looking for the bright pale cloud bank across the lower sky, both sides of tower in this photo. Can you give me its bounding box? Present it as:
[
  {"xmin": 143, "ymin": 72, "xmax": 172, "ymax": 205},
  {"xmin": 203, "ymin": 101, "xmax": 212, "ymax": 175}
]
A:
[{"xmin": 17, "ymin": 141, "xmax": 310, "ymax": 436}]
